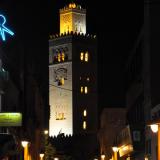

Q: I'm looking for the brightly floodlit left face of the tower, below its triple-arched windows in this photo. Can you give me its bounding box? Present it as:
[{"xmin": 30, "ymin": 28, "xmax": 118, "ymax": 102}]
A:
[{"xmin": 49, "ymin": 62, "xmax": 73, "ymax": 136}]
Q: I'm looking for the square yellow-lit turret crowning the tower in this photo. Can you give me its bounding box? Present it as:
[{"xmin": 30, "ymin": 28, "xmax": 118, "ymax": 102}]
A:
[{"xmin": 60, "ymin": 3, "xmax": 86, "ymax": 34}]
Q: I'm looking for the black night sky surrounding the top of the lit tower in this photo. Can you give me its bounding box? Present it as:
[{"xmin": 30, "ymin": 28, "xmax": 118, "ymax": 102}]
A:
[{"xmin": 0, "ymin": 0, "xmax": 144, "ymax": 107}]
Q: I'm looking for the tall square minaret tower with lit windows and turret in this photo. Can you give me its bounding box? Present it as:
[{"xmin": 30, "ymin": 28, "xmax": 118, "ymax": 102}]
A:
[{"xmin": 49, "ymin": 3, "xmax": 97, "ymax": 136}]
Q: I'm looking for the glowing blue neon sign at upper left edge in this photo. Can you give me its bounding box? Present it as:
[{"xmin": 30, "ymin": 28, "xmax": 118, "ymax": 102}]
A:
[{"xmin": 0, "ymin": 14, "xmax": 14, "ymax": 41}]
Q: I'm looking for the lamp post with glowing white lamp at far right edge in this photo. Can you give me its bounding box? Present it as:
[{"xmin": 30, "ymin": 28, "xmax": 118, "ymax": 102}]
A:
[{"xmin": 148, "ymin": 120, "xmax": 160, "ymax": 160}]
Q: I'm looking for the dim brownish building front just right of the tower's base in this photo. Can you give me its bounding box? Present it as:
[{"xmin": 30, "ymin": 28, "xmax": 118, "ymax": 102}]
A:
[{"xmin": 98, "ymin": 107, "xmax": 126, "ymax": 159}]
